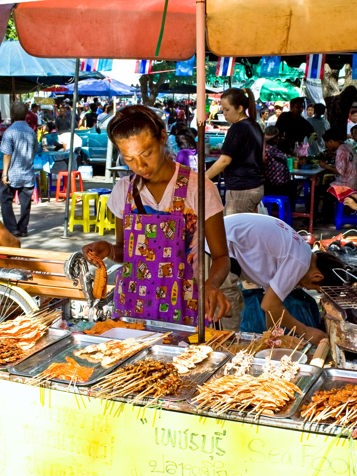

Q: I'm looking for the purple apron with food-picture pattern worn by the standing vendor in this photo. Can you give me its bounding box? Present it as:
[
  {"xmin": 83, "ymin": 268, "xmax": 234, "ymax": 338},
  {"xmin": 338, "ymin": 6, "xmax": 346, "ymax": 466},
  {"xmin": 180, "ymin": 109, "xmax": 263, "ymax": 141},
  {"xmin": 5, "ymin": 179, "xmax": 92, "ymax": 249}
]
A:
[{"xmin": 113, "ymin": 165, "xmax": 198, "ymax": 325}]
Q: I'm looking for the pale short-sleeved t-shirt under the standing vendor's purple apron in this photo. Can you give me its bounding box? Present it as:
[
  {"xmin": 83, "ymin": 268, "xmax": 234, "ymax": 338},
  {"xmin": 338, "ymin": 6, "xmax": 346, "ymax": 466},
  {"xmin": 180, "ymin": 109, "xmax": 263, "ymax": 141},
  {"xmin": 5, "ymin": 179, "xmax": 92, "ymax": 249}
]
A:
[{"xmin": 108, "ymin": 164, "xmax": 224, "ymax": 276}]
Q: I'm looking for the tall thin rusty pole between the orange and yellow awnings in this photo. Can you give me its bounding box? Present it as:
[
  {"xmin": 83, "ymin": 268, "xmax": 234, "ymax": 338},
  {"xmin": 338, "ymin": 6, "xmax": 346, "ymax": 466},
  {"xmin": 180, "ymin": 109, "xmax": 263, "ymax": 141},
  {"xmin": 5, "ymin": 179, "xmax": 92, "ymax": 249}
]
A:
[{"xmin": 196, "ymin": 0, "xmax": 206, "ymax": 343}]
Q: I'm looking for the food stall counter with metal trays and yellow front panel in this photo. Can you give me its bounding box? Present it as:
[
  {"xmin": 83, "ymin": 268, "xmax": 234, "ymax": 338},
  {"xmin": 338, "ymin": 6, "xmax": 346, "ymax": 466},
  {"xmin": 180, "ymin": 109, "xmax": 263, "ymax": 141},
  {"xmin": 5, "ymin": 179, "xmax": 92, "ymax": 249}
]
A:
[{"xmin": 0, "ymin": 315, "xmax": 357, "ymax": 476}]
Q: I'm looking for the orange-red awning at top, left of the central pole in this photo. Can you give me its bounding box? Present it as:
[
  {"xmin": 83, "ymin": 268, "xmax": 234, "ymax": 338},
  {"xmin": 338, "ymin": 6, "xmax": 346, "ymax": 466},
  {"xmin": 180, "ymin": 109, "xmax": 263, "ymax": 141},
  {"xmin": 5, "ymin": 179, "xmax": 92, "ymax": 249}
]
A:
[{"xmin": 15, "ymin": 0, "xmax": 196, "ymax": 60}]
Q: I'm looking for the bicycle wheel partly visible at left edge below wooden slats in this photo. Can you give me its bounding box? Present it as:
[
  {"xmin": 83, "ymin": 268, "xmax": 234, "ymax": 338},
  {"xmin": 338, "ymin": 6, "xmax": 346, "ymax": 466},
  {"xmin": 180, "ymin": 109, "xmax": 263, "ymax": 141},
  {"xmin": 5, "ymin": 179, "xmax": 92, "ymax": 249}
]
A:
[{"xmin": 0, "ymin": 284, "xmax": 38, "ymax": 321}]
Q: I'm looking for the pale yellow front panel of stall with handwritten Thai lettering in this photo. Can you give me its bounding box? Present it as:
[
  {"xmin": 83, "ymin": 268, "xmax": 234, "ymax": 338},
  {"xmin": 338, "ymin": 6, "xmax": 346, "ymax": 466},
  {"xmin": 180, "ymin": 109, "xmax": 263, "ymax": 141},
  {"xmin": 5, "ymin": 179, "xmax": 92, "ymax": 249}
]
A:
[{"xmin": 0, "ymin": 380, "xmax": 357, "ymax": 476}]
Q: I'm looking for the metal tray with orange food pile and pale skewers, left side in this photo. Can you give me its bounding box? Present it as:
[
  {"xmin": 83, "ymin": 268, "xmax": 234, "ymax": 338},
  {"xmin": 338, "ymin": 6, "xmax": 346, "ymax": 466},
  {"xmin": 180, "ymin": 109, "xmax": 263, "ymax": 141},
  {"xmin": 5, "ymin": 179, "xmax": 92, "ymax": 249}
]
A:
[{"xmin": 8, "ymin": 334, "xmax": 145, "ymax": 387}]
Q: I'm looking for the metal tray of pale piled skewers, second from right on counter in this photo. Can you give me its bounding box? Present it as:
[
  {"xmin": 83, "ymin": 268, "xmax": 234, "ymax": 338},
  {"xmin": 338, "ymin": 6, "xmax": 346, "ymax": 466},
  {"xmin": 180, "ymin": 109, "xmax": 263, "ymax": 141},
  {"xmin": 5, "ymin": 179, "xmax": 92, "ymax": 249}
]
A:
[{"xmin": 196, "ymin": 358, "xmax": 321, "ymax": 419}]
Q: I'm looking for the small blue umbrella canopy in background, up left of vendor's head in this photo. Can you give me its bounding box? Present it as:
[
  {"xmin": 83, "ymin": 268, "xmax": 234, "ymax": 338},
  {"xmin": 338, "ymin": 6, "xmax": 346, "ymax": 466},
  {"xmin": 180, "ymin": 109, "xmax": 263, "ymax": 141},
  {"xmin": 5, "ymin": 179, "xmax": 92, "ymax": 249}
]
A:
[{"xmin": 66, "ymin": 78, "xmax": 136, "ymax": 97}]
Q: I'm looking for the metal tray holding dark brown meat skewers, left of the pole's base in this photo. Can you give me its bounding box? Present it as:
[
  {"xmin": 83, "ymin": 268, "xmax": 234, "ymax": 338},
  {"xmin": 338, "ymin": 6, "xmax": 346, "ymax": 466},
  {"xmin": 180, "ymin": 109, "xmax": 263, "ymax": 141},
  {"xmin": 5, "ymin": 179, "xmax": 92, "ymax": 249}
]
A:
[{"xmin": 110, "ymin": 345, "xmax": 230, "ymax": 401}]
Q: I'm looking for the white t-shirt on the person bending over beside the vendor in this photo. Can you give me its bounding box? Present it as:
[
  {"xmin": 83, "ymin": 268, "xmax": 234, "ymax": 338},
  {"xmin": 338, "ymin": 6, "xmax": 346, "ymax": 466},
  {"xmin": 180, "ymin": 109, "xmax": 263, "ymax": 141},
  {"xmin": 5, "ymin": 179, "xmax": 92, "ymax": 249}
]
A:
[{"xmin": 224, "ymin": 213, "xmax": 312, "ymax": 301}]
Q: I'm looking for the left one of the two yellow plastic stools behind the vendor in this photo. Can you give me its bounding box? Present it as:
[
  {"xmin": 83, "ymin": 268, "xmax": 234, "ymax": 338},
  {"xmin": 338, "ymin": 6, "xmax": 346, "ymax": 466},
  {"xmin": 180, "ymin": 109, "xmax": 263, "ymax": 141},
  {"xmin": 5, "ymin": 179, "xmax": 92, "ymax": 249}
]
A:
[{"xmin": 68, "ymin": 192, "xmax": 98, "ymax": 233}]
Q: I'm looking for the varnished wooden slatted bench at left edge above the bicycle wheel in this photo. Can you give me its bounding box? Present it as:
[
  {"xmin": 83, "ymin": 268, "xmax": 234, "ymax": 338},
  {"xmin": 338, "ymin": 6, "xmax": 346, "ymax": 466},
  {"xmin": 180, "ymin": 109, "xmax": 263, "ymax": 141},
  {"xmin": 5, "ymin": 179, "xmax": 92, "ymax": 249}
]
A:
[{"xmin": 0, "ymin": 246, "xmax": 85, "ymax": 299}]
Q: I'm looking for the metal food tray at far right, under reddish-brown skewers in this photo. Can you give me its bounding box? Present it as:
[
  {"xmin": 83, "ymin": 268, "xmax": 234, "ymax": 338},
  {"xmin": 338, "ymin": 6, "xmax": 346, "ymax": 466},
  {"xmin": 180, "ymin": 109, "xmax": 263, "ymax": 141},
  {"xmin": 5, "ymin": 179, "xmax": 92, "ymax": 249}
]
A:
[{"xmin": 295, "ymin": 368, "xmax": 357, "ymax": 420}]
